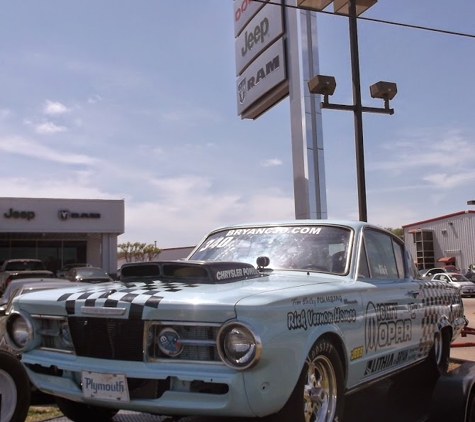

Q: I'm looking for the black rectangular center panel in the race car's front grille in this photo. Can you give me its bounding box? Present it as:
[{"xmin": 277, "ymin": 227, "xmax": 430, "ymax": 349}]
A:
[{"xmin": 68, "ymin": 317, "xmax": 144, "ymax": 362}]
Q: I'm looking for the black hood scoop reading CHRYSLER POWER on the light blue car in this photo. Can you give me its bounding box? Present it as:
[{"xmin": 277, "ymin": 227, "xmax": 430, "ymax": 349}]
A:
[{"xmin": 120, "ymin": 261, "xmax": 261, "ymax": 284}]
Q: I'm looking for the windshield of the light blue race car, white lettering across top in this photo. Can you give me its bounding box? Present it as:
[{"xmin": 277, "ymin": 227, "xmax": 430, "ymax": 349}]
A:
[{"xmin": 189, "ymin": 225, "xmax": 353, "ymax": 274}]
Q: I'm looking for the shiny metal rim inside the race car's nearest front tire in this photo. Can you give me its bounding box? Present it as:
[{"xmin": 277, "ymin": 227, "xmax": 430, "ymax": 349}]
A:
[{"xmin": 303, "ymin": 355, "xmax": 338, "ymax": 422}]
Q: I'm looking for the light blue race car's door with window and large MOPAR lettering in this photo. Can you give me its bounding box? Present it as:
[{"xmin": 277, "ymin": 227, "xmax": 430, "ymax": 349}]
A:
[{"xmin": 358, "ymin": 228, "xmax": 422, "ymax": 381}]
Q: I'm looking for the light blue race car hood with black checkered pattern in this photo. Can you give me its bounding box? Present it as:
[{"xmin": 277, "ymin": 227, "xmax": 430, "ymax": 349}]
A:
[{"xmin": 13, "ymin": 262, "xmax": 342, "ymax": 322}]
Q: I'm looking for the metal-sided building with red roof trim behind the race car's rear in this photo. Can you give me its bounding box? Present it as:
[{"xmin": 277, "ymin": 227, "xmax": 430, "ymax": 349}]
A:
[{"xmin": 402, "ymin": 211, "xmax": 475, "ymax": 272}]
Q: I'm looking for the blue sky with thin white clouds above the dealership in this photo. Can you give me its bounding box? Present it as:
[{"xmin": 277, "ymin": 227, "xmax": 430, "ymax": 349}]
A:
[{"xmin": 0, "ymin": 0, "xmax": 475, "ymax": 248}]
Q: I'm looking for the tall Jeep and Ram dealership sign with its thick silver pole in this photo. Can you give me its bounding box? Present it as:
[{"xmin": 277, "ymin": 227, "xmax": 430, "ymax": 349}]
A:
[{"xmin": 234, "ymin": 0, "xmax": 327, "ymax": 219}]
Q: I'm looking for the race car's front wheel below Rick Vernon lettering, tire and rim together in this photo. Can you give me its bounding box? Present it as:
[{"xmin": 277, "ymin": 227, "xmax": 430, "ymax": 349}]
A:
[{"xmin": 271, "ymin": 339, "xmax": 344, "ymax": 422}]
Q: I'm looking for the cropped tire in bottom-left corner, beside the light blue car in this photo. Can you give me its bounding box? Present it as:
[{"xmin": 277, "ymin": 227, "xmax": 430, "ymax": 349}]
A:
[{"xmin": 0, "ymin": 351, "xmax": 30, "ymax": 422}]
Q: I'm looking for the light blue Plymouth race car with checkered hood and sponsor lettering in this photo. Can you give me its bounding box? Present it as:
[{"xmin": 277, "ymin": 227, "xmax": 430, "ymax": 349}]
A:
[{"xmin": 2, "ymin": 220, "xmax": 467, "ymax": 422}]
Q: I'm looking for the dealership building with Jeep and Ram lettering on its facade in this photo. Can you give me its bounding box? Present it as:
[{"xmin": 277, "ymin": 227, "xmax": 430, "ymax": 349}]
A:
[{"xmin": 0, "ymin": 198, "xmax": 124, "ymax": 273}]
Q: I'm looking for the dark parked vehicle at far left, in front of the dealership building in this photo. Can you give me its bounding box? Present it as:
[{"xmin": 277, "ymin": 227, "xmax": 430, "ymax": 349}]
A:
[{"xmin": 0, "ymin": 259, "xmax": 54, "ymax": 295}]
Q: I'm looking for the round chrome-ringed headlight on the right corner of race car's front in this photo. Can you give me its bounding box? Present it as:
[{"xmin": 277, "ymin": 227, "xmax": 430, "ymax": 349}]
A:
[{"xmin": 218, "ymin": 322, "xmax": 262, "ymax": 370}]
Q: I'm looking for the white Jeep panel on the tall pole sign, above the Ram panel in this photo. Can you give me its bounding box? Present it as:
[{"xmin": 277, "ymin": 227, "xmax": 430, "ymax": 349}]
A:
[{"xmin": 234, "ymin": 4, "xmax": 284, "ymax": 75}]
